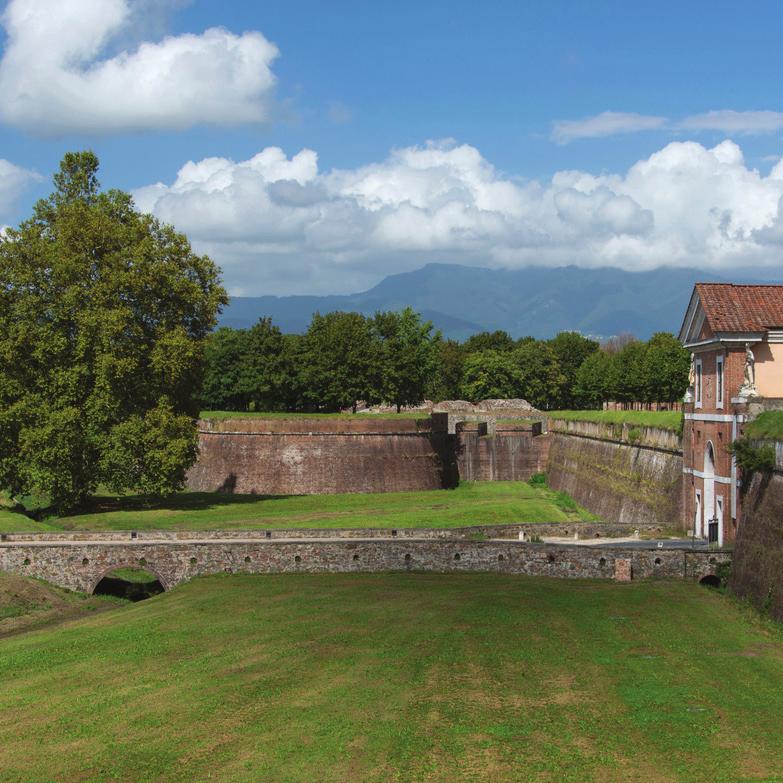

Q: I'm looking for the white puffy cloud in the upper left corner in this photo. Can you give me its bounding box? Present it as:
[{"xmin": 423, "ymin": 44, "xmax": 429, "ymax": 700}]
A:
[{"xmin": 0, "ymin": 0, "xmax": 278, "ymax": 135}]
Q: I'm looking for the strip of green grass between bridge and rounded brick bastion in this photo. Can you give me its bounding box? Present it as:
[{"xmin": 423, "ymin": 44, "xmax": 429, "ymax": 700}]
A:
[{"xmin": 41, "ymin": 481, "xmax": 594, "ymax": 530}]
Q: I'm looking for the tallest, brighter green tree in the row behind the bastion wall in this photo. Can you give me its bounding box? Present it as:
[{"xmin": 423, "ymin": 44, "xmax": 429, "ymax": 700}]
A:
[{"xmin": 372, "ymin": 307, "xmax": 440, "ymax": 413}]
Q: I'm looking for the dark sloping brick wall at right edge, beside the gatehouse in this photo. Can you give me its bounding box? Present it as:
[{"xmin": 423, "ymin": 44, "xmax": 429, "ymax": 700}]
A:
[{"xmin": 731, "ymin": 460, "xmax": 783, "ymax": 621}]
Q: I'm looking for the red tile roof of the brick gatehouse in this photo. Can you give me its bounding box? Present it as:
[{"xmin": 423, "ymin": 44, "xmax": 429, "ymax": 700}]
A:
[{"xmin": 696, "ymin": 283, "xmax": 783, "ymax": 332}]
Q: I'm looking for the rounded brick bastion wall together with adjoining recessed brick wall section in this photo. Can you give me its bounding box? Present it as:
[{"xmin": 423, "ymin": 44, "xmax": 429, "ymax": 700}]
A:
[{"xmin": 187, "ymin": 419, "xmax": 549, "ymax": 495}]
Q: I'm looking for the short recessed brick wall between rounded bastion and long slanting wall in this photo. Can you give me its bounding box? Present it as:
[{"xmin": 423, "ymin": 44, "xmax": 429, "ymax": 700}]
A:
[{"xmin": 457, "ymin": 423, "xmax": 549, "ymax": 481}]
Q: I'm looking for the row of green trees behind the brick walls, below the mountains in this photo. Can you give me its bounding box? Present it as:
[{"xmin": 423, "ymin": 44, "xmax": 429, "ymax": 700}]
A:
[{"xmin": 201, "ymin": 308, "xmax": 689, "ymax": 412}]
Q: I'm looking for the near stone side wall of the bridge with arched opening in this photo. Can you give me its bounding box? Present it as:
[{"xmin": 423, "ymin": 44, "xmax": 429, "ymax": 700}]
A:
[{"xmin": 0, "ymin": 539, "xmax": 730, "ymax": 592}]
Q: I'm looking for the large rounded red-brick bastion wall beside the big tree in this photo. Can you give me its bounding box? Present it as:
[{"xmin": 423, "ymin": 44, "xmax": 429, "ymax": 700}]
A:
[{"xmin": 187, "ymin": 418, "xmax": 456, "ymax": 495}]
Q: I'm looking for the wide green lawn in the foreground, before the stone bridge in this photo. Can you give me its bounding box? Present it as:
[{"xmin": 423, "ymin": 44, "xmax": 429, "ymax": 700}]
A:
[{"xmin": 0, "ymin": 574, "xmax": 783, "ymax": 783}]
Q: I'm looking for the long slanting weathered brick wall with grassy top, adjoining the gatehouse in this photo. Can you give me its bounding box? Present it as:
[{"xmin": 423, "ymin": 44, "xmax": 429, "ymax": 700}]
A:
[{"xmin": 547, "ymin": 421, "xmax": 686, "ymax": 530}]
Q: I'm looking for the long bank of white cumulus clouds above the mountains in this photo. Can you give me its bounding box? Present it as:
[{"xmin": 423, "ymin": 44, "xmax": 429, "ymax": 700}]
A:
[{"xmin": 135, "ymin": 140, "xmax": 783, "ymax": 294}]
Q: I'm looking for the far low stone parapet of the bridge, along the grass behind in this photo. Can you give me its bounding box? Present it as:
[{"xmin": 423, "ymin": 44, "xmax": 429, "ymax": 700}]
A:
[{"xmin": 0, "ymin": 522, "xmax": 663, "ymax": 545}]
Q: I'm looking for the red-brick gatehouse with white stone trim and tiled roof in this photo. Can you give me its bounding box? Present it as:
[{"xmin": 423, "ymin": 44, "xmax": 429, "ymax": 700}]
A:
[{"xmin": 680, "ymin": 283, "xmax": 783, "ymax": 545}]
